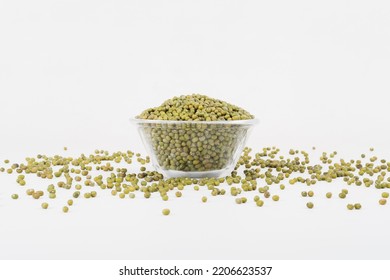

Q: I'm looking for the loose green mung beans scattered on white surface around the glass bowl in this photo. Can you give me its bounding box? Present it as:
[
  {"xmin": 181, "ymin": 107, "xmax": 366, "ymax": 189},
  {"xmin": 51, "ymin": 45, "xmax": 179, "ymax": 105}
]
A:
[{"xmin": 0, "ymin": 135, "xmax": 390, "ymax": 212}]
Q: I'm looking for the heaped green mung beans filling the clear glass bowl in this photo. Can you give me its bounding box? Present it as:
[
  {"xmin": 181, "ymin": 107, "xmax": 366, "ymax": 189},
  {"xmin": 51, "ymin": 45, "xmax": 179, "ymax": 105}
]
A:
[{"xmin": 137, "ymin": 94, "xmax": 254, "ymax": 172}]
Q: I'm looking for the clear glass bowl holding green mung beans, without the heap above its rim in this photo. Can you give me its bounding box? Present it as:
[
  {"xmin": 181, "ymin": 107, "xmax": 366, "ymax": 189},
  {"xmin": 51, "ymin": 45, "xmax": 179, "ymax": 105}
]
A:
[{"xmin": 131, "ymin": 118, "xmax": 258, "ymax": 178}]
